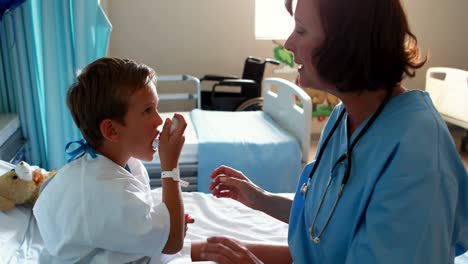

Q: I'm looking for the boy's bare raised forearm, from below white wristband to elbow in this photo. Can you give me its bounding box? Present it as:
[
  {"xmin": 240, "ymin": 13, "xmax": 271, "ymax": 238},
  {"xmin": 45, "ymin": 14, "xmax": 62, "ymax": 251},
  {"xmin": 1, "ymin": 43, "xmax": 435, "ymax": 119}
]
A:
[{"xmin": 162, "ymin": 178, "xmax": 185, "ymax": 254}]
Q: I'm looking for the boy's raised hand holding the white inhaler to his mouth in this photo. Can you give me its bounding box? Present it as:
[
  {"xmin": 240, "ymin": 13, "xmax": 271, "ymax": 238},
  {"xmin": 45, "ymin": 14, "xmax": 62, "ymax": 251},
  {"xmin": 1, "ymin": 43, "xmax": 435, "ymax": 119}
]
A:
[{"xmin": 158, "ymin": 113, "xmax": 187, "ymax": 171}]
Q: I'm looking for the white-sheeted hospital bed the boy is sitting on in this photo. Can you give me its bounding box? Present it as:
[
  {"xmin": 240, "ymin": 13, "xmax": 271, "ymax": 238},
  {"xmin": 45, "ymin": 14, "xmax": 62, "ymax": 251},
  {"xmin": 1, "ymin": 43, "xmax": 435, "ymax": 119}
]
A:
[{"xmin": 0, "ymin": 160, "xmax": 468, "ymax": 264}]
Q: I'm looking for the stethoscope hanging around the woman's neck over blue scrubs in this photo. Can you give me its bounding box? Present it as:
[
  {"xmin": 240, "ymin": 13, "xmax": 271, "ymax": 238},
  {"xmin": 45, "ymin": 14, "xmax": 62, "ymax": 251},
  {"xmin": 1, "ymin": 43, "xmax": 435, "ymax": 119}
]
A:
[{"xmin": 301, "ymin": 89, "xmax": 393, "ymax": 244}]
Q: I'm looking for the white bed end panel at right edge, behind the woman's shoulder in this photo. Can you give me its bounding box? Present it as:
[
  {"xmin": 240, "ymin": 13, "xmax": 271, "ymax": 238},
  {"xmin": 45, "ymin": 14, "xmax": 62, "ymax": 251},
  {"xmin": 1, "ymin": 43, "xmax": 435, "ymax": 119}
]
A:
[{"xmin": 426, "ymin": 67, "xmax": 468, "ymax": 152}]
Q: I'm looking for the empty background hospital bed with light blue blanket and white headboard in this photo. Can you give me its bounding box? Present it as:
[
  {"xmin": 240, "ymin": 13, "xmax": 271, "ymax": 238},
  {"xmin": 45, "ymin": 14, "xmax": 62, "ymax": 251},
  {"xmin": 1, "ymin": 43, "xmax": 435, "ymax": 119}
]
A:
[{"xmin": 145, "ymin": 75, "xmax": 312, "ymax": 192}]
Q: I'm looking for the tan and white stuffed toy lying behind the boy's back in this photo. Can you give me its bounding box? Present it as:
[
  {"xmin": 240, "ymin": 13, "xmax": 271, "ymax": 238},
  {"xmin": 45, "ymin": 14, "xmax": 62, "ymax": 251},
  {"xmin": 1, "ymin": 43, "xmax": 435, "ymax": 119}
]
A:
[{"xmin": 0, "ymin": 161, "xmax": 56, "ymax": 211}]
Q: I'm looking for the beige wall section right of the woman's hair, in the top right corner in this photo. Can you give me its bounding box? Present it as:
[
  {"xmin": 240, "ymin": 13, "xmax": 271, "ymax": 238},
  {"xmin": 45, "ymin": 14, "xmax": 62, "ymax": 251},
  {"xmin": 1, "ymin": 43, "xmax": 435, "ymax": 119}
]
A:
[{"xmin": 403, "ymin": 0, "xmax": 468, "ymax": 88}]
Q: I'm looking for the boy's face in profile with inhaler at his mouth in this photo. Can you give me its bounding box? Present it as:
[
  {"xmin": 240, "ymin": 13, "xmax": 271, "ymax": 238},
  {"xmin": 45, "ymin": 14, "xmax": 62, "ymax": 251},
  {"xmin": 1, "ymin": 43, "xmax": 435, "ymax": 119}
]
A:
[{"xmin": 120, "ymin": 82, "xmax": 163, "ymax": 161}]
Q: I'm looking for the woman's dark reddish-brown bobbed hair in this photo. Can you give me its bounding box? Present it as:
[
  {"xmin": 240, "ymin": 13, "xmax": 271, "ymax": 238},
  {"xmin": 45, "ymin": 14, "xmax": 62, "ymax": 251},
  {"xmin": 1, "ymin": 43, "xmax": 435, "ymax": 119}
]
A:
[{"xmin": 308, "ymin": 0, "xmax": 427, "ymax": 92}]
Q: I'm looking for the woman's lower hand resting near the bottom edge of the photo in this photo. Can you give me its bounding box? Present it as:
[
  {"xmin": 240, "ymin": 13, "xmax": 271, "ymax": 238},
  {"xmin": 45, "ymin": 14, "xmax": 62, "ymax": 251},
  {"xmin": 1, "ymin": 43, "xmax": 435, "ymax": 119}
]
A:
[{"xmin": 200, "ymin": 237, "xmax": 263, "ymax": 264}]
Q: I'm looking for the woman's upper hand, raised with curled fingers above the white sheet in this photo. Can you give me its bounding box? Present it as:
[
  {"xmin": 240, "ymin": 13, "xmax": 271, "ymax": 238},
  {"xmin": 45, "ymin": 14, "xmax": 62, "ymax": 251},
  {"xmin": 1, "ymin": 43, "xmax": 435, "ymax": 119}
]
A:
[{"xmin": 208, "ymin": 165, "xmax": 265, "ymax": 209}]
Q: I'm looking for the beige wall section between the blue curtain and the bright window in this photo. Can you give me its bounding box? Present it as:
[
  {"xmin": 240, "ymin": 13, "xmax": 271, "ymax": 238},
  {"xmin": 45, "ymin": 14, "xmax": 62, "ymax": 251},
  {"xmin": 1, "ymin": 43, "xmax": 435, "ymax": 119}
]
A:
[{"xmin": 99, "ymin": 0, "xmax": 288, "ymax": 111}]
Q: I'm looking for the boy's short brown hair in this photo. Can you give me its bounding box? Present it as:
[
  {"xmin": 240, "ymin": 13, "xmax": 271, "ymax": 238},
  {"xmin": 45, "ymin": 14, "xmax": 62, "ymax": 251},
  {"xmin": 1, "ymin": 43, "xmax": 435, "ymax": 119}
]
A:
[{"xmin": 67, "ymin": 58, "xmax": 156, "ymax": 149}]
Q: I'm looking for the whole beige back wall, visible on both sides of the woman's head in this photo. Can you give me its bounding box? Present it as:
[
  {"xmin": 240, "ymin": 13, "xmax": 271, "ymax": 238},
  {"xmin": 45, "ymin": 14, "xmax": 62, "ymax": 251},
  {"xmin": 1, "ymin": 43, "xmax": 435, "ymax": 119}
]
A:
[{"xmin": 102, "ymin": 0, "xmax": 468, "ymax": 102}]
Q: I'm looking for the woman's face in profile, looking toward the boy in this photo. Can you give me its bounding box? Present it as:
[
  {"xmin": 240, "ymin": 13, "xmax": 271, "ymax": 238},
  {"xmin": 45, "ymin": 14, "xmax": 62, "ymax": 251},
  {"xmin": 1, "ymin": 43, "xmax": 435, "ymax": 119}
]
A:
[{"xmin": 284, "ymin": 0, "xmax": 333, "ymax": 90}]
